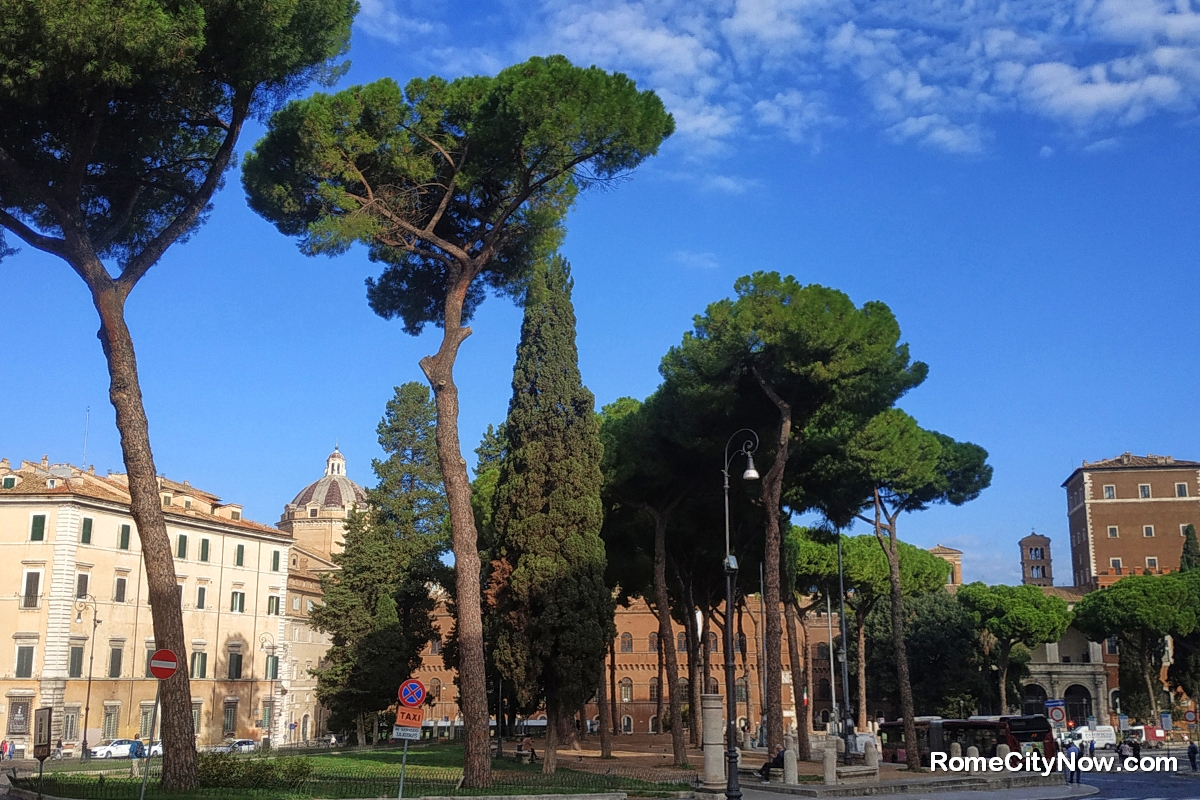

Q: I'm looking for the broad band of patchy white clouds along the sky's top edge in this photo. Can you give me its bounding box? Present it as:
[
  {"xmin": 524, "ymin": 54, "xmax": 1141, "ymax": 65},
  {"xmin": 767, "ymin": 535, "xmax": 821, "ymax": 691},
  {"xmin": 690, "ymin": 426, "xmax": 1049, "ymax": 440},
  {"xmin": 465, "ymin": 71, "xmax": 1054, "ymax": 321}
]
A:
[{"xmin": 359, "ymin": 0, "xmax": 1200, "ymax": 158}]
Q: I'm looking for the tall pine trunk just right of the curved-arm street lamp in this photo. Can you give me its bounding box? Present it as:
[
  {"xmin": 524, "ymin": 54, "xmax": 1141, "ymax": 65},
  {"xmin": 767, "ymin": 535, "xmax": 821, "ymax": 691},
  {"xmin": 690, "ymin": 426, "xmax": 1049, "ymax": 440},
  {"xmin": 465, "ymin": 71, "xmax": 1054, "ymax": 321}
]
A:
[{"xmin": 762, "ymin": 407, "xmax": 792, "ymax": 753}]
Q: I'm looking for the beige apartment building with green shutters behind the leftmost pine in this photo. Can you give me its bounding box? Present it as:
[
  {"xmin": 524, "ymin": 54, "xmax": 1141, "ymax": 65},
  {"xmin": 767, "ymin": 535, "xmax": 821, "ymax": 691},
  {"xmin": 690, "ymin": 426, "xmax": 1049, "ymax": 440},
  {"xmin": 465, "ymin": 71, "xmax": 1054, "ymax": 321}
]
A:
[{"xmin": 0, "ymin": 457, "xmax": 293, "ymax": 754}]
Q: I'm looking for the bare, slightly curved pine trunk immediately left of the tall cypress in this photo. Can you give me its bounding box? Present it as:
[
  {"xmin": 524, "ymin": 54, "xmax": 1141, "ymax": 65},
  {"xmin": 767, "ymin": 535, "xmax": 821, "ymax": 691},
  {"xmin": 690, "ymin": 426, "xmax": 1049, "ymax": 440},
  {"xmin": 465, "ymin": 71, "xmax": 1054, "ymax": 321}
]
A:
[{"xmin": 421, "ymin": 284, "xmax": 492, "ymax": 788}]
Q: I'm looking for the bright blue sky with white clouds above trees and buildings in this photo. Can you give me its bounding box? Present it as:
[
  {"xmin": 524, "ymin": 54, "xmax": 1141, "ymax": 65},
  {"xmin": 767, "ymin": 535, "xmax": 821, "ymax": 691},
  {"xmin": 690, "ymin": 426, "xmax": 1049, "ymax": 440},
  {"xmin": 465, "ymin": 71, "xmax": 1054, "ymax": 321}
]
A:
[{"xmin": 0, "ymin": 0, "xmax": 1200, "ymax": 583}]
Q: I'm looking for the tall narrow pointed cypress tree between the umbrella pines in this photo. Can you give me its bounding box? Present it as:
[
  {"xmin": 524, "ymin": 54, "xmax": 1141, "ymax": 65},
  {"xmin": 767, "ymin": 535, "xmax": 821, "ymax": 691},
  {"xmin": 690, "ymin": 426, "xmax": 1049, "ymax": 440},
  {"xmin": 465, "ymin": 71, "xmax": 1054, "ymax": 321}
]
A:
[{"xmin": 492, "ymin": 257, "xmax": 614, "ymax": 772}]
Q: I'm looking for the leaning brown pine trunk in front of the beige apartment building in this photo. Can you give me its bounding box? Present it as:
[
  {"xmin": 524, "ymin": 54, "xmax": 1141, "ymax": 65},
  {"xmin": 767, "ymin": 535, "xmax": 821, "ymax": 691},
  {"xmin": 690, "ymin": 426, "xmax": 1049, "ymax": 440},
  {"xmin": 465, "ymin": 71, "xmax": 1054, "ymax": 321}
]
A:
[{"xmin": 92, "ymin": 287, "xmax": 197, "ymax": 789}]
